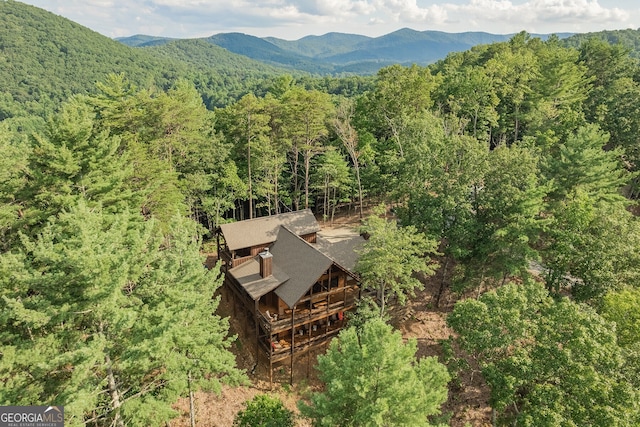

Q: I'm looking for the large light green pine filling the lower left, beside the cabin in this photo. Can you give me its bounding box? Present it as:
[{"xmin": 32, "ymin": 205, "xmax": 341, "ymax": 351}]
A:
[{"xmin": 0, "ymin": 204, "xmax": 242, "ymax": 425}]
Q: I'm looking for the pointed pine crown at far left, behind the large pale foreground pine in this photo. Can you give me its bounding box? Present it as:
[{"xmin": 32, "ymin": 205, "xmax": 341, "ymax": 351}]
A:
[{"xmin": 12, "ymin": 98, "xmax": 140, "ymax": 244}]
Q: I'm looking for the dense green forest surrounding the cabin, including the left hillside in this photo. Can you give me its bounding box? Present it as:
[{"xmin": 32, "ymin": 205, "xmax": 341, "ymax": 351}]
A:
[{"xmin": 0, "ymin": 1, "xmax": 640, "ymax": 427}]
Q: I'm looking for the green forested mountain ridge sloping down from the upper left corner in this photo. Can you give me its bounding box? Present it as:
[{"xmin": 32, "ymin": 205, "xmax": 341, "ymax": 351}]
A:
[{"xmin": 0, "ymin": 0, "xmax": 304, "ymax": 119}]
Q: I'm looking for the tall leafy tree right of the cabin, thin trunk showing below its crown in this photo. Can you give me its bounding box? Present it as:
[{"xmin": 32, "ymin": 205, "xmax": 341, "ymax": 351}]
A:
[{"xmin": 398, "ymin": 114, "xmax": 489, "ymax": 305}]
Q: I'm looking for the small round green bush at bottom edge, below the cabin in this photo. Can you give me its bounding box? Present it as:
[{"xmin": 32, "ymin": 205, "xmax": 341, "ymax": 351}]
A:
[{"xmin": 233, "ymin": 394, "xmax": 294, "ymax": 427}]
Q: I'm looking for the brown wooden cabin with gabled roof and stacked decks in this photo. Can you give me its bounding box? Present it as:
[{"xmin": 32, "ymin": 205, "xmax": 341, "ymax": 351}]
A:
[{"xmin": 218, "ymin": 210, "xmax": 364, "ymax": 382}]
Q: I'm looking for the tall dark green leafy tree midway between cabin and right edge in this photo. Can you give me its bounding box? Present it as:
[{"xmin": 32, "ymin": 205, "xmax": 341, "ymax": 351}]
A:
[{"xmin": 459, "ymin": 144, "xmax": 548, "ymax": 292}]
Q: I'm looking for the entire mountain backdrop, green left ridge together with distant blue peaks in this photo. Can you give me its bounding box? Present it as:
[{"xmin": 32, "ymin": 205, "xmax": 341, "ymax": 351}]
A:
[{"xmin": 0, "ymin": 0, "xmax": 640, "ymax": 116}]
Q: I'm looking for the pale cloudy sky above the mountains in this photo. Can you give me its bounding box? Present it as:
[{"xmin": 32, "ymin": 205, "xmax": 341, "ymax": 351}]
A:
[{"xmin": 17, "ymin": 0, "xmax": 640, "ymax": 40}]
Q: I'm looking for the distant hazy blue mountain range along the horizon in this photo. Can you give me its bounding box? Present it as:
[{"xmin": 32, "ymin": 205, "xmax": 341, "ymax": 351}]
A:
[{"xmin": 116, "ymin": 28, "xmax": 572, "ymax": 74}]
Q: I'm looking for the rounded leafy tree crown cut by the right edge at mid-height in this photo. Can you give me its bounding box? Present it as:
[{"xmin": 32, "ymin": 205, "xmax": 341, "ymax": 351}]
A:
[{"xmin": 541, "ymin": 191, "xmax": 640, "ymax": 305}]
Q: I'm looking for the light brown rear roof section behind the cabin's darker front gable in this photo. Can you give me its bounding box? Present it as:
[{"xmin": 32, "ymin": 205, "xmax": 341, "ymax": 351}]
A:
[{"xmin": 220, "ymin": 209, "xmax": 320, "ymax": 251}]
